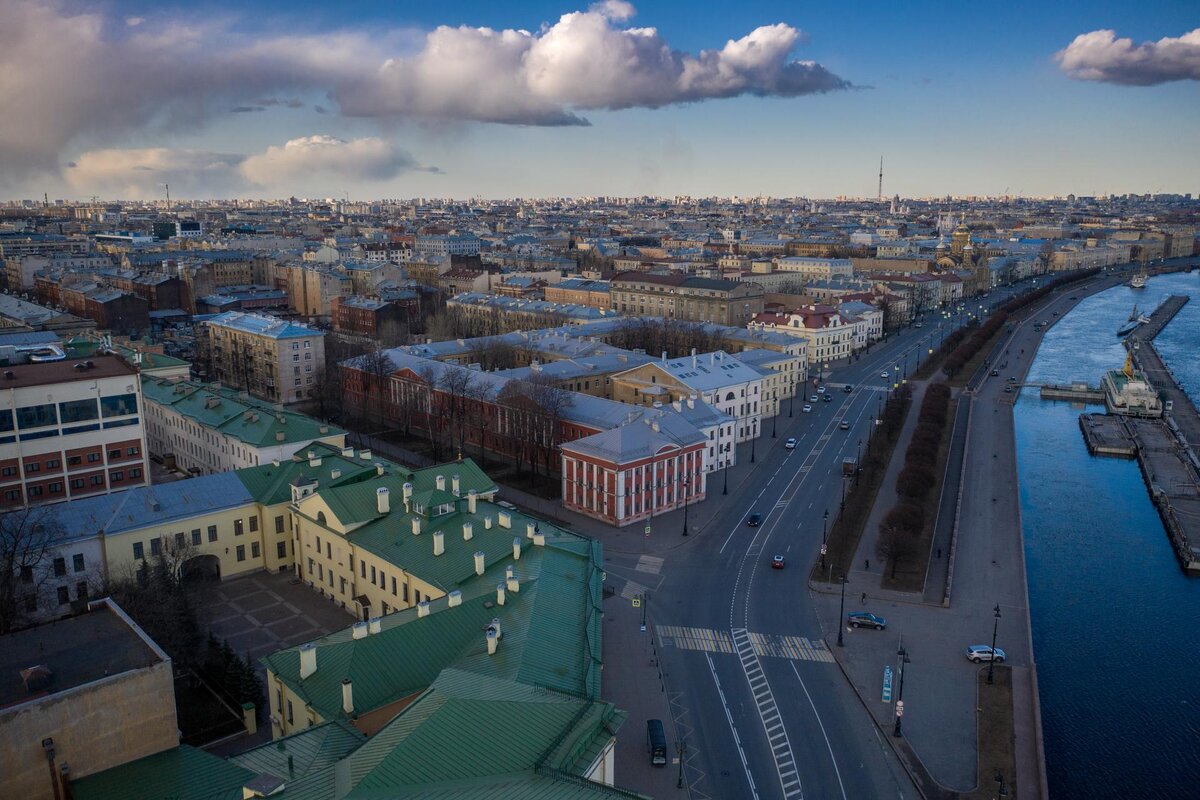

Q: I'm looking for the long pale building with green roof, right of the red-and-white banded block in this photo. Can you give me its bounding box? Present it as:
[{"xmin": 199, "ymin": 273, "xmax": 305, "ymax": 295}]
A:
[{"xmin": 142, "ymin": 375, "xmax": 346, "ymax": 475}]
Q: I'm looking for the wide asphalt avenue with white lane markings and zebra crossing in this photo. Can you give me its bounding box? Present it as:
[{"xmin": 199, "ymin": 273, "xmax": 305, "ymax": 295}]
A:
[{"xmin": 654, "ymin": 271, "xmax": 1118, "ymax": 799}]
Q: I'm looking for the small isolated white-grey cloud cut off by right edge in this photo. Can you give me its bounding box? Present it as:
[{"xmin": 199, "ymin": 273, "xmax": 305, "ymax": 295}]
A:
[{"xmin": 1055, "ymin": 28, "xmax": 1200, "ymax": 86}]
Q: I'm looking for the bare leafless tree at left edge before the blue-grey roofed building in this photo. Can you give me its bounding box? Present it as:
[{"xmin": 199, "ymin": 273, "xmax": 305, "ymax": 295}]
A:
[{"xmin": 0, "ymin": 506, "xmax": 64, "ymax": 633}]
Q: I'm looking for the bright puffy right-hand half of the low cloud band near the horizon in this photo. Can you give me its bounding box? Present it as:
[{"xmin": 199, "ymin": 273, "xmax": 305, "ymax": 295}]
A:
[{"xmin": 241, "ymin": 136, "xmax": 427, "ymax": 186}]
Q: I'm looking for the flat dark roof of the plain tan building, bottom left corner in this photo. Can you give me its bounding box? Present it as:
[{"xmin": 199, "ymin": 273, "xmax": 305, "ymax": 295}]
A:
[{"xmin": 0, "ymin": 604, "xmax": 162, "ymax": 709}]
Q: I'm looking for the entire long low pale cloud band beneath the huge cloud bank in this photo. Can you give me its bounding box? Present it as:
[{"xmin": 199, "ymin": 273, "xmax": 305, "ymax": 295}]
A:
[{"xmin": 64, "ymin": 134, "xmax": 440, "ymax": 199}]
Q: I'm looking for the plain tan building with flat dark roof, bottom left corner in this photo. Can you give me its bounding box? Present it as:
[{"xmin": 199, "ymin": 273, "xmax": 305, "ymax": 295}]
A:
[{"xmin": 0, "ymin": 599, "xmax": 179, "ymax": 800}]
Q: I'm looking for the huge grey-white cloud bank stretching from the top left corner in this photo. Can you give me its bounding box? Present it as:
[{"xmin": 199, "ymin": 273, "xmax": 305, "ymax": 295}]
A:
[{"xmin": 0, "ymin": 0, "xmax": 850, "ymax": 180}]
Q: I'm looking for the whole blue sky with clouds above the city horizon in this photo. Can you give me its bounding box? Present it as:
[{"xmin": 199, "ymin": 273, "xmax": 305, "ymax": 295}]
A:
[{"xmin": 0, "ymin": 0, "xmax": 1200, "ymax": 199}]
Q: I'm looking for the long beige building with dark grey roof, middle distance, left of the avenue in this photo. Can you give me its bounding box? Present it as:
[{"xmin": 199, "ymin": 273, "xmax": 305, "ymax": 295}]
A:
[{"xmin": 610, "ymin": 272, "xmax": 763, "ymax": 326}]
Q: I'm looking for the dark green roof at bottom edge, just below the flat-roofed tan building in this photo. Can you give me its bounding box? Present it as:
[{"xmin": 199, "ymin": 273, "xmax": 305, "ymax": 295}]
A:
[{"xmin": 71, "ymin": 745, "xmax": 256, "ymax": 800}]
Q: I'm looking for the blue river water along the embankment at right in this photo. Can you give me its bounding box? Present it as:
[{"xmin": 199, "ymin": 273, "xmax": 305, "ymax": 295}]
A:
[{"xmin": 1015, "ymin": 272, "xmax": 1200, "ymax": 800}]
